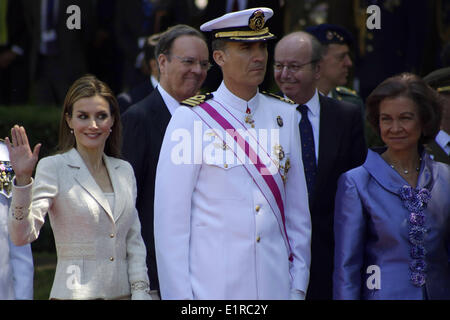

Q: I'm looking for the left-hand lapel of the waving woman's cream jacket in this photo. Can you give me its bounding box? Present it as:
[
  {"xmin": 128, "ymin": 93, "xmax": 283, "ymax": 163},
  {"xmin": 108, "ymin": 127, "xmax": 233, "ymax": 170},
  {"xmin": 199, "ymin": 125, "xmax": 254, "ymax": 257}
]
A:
[{"xmin": 67, "ymin": 149, "xmax": 114, "ymax": 221}]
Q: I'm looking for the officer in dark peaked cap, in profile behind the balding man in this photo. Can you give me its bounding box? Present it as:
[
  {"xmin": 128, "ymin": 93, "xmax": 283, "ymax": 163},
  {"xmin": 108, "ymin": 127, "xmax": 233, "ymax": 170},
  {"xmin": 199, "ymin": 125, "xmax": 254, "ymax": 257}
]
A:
[{"xmin": 305, "ymin": 24, "xmax": 364, "ymax": 111}]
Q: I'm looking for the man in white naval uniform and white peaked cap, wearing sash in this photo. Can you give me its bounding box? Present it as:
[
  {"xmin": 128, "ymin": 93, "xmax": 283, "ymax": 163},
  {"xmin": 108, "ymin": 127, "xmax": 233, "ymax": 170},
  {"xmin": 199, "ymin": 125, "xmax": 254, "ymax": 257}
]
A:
[{"xmin": 154, "ymin": 8, "xmax": 311, "ymax": 300}]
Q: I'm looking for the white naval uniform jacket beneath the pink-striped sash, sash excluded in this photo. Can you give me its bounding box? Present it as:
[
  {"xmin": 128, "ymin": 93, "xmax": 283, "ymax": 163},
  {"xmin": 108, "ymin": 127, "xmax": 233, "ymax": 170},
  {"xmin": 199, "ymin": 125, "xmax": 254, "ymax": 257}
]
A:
[{"xmin": 154, "ymin": 83, "xmax": 311, "ymax": 299}]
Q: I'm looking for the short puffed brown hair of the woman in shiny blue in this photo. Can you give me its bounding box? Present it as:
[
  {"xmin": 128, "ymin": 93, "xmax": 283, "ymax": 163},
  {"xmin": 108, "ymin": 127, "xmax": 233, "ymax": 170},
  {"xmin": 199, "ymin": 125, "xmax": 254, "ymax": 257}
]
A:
[{"xmin": 366, "ymin": 73, "xmax": 442, "ymax": 144}]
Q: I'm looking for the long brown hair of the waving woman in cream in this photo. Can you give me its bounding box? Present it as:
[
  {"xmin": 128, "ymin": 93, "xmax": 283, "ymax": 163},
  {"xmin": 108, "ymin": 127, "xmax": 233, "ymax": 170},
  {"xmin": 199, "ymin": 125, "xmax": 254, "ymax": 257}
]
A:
[{"xmin": 57, "ymin": 74, "xmax": 122, "ymax": 158}]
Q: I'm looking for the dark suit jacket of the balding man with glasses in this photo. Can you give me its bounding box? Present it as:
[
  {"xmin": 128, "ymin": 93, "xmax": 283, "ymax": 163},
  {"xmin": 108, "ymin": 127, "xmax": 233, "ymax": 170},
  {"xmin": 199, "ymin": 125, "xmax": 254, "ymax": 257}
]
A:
[{"xmin": 306, "ymin": 95, "xmax": 367, "ymax": 300}]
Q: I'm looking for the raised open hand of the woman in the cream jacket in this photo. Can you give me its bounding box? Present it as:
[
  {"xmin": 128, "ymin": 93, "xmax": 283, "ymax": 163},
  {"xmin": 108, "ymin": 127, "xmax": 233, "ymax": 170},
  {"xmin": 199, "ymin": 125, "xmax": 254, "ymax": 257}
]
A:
[{"xmin": 5, "ymin": 125, "xmax": 41, "ymax": 186}]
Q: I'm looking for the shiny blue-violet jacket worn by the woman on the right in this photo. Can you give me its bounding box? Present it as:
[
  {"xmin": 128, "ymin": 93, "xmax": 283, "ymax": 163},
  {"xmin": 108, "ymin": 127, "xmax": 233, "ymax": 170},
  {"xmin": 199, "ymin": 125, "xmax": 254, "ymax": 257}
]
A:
[{"xmin": 333, "ymin": 150, "xmax": 450, "ymax": 300}]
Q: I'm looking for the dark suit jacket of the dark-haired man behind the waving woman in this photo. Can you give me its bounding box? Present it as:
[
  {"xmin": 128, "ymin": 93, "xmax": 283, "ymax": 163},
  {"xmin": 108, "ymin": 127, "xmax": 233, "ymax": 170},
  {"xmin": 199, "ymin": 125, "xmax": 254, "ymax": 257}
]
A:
[{"xmin": 122, "ymin": 89, "xmax": 171, "ymax": 290}]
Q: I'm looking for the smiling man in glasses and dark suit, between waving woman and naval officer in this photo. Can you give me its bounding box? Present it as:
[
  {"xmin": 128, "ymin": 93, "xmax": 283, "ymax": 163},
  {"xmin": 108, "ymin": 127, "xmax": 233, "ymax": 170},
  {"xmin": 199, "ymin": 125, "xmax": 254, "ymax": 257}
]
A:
[{"xmin": 122, "ymin": 25, "xmax": 209, "ymax": 298}]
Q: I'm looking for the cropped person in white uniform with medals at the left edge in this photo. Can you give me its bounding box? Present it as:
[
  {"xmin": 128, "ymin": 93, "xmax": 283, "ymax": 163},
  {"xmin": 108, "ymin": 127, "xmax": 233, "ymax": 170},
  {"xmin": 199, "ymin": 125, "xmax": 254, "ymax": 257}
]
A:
[{"xmin": 0, "ymin": 140, "xmax": 34, "ymax": 300}]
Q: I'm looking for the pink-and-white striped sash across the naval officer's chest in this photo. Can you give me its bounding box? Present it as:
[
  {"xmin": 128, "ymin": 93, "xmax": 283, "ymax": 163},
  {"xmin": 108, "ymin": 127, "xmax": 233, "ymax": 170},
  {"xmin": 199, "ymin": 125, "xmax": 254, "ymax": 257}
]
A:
[{"xmin": 192, "ymin": 102, "xmax": 292, "ymax": 260}]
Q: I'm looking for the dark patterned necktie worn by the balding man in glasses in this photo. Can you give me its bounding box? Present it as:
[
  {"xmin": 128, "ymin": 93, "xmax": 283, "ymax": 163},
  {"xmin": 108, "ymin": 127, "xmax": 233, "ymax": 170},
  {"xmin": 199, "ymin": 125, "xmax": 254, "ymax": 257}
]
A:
[{"xmin": 297, "ymin": 105, "xmax": 317, "ymax": 197}]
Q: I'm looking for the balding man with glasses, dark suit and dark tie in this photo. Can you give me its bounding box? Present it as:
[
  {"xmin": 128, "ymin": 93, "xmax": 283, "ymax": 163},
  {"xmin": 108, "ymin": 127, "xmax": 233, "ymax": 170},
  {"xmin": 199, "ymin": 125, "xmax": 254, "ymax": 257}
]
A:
[{"xmin": 274, "ymin": 32, "xmax": 366, "ymax": 300}]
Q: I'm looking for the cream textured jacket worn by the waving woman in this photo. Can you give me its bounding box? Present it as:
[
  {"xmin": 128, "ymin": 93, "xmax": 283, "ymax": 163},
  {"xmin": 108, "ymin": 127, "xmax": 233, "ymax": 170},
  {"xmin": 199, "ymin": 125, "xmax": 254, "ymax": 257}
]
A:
[{"xmin": 8, "ymin": 149, "xmax": 148, "ymax": 299}]
